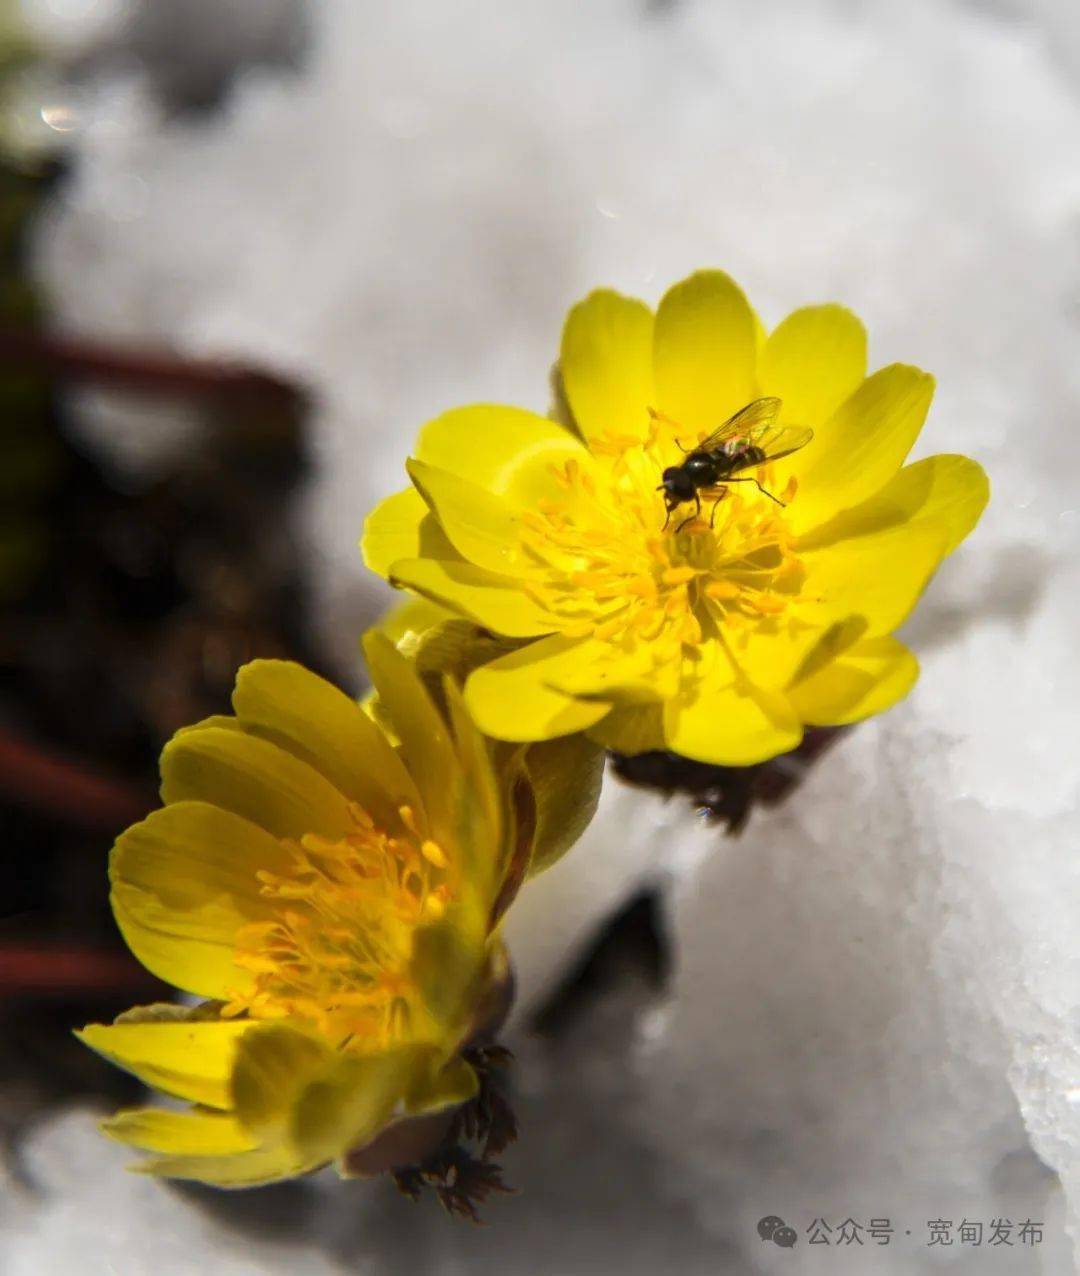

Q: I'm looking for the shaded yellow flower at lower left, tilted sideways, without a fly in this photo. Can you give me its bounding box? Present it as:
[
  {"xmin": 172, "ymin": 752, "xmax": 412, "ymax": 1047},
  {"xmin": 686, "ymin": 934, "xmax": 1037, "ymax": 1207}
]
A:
[{"xmin": 79, "ymin": 634, "xmax": 597, "ymax": 1187}]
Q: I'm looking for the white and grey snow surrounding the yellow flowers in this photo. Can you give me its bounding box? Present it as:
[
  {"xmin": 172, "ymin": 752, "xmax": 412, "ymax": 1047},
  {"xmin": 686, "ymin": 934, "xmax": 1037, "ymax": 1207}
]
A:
[{"xmin": 0, "ymin": 0, "xmax": 1080, "ymax": 1276}]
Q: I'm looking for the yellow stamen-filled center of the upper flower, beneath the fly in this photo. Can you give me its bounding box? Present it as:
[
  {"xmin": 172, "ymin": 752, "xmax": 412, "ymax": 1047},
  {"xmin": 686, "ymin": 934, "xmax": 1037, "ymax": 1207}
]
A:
[{"xmin": 522, "ymin": 417, "xmax": 803, "ymax": 660}]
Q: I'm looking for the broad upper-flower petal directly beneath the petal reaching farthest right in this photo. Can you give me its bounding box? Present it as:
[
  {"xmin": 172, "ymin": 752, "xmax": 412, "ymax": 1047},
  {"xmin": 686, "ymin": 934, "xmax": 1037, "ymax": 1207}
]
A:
[{"xmin": 798, "ymin": 519, "xmax": 947, "ymax": 638}]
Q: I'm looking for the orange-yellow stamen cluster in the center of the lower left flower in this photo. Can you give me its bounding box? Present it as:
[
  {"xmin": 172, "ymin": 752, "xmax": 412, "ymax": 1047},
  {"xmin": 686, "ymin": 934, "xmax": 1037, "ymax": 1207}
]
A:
[{"xmin": 222, "ymin": 805, "xmax": 449, "ymax": 1048}]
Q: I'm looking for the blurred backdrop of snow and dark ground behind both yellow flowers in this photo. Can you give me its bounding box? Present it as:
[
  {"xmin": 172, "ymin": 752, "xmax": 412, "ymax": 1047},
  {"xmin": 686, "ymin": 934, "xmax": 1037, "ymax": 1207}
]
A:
[{"xmin": 0, "ymin": 0, "xmax": 1080, "ymax": 1276}]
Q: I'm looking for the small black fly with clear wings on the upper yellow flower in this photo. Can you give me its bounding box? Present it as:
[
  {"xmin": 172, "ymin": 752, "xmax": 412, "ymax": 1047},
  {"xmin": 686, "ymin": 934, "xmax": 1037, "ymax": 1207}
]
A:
[{"xmin": 649, "ymin": 398, "xmax": 813, "ymax": 532}]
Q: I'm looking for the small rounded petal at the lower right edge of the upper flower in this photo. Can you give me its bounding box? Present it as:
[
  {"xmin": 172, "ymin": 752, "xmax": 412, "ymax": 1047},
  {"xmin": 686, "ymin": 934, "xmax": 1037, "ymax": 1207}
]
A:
[{"xmin": 788, "ymin": 637, "xmax": 919, "ymax": 726}]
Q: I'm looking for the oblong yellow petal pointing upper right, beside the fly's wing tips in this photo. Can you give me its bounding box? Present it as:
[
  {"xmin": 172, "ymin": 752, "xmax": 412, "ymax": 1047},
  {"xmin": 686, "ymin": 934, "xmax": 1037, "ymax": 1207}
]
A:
[{"xmin": 777, "ymin": 364, "xmax": 933, "ymax": 532}]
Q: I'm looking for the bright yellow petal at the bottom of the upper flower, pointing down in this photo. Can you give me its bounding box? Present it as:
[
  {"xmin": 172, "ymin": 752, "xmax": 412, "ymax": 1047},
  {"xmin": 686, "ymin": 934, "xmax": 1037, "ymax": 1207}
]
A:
[{"xmin": 664, "ymin": 643, "xmax": 803, "ymax": 767}]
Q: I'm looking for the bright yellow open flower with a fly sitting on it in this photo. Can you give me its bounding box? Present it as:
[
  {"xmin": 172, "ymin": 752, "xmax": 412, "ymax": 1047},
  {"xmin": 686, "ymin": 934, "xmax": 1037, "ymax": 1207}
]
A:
[{"xmin": 363, "ymin": 272, "xmax": 988, "ymax": 764}]
